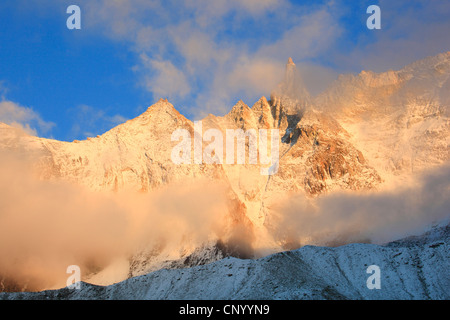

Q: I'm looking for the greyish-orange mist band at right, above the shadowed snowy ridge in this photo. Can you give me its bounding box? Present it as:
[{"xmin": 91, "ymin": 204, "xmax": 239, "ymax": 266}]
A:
[{"xmin": 268, "ymin": 165, "xmax": 450, "ymax": 248}]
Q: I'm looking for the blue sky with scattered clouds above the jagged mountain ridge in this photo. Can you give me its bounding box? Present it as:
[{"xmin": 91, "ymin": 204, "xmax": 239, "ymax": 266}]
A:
[{"xmin": 0, "ymin": 0, "xmax": 450, "ymax": 141}]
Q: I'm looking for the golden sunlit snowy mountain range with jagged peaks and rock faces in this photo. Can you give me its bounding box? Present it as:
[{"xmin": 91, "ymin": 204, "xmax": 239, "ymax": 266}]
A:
[{"xmin": 0, "ymin": 53, "xmax": 450, "ymax": 290}]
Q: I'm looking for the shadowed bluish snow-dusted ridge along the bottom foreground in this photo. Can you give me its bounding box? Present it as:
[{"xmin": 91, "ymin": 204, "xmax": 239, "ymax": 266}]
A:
[{"xmin": 0, "ymin": 225, "xmax": 450, "ymax": 300}]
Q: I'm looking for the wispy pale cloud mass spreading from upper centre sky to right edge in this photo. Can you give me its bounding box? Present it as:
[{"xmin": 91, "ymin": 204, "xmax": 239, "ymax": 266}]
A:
[{"xmin": 34, "ymin": 0, "xmax": 450, "ymax": 119}]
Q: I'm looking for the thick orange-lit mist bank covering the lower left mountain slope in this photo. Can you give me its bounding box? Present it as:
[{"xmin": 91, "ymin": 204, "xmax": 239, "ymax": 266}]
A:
[{"xmin": 0, "ymin": 152, "xmax": 239, "ymax": 291}]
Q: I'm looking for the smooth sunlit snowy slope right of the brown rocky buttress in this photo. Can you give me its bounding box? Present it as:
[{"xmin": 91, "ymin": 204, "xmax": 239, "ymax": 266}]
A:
[{"xmin": 315, "ymin": 52, "xmax": 450, "ymax": 186}]
